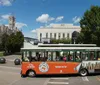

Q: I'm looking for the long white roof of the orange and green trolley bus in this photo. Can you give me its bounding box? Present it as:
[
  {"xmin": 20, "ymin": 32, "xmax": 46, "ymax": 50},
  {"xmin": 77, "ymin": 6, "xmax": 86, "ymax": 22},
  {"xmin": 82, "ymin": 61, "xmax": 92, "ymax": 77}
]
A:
[{"xmin": 21, "ymin": 42, "xmax": 100, "ymax": 51}]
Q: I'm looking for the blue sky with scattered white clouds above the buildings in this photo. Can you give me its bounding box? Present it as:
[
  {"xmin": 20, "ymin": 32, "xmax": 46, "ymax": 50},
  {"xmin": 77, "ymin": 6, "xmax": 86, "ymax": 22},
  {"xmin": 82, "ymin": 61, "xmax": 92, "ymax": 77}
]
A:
[{"xmin": 0, "ymin": 0, "xmax": 100, "ymax": 38}]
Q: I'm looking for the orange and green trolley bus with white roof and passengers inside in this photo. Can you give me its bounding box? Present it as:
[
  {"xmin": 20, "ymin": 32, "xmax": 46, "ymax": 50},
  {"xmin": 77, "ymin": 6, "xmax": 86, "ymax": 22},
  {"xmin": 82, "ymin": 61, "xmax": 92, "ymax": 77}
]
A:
[{"xmin": 21, "ymin": 44, "xmax": 100, "ymax": 77}]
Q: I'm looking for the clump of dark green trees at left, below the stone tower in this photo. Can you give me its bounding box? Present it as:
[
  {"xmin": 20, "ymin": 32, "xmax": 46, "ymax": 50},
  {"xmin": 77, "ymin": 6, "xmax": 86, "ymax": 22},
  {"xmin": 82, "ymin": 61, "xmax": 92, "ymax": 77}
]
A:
[{"xmin": 2, "ymin": 32, "xmax": 24, "ymax": 53}]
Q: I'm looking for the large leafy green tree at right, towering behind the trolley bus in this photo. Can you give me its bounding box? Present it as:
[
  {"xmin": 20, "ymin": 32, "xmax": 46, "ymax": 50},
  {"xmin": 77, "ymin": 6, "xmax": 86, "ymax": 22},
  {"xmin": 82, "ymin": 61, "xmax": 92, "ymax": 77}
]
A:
[{"xmin": 77, "ymin": 6, "xmax": 100, "ymax": 46}]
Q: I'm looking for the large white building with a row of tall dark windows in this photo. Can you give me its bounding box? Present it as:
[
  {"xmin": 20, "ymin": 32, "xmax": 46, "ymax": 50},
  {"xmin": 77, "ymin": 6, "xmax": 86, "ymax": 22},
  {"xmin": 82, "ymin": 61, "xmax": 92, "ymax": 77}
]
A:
[{"xmin": 36, "ymin": 24, "xmax": 81, "ymax": 41}]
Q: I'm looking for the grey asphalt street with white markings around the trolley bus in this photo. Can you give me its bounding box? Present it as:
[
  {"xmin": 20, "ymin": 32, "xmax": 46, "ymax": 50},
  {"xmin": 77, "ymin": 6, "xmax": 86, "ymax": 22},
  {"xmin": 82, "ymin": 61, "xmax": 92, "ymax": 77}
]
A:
[{"xmin": 0, "ymin": 55, "xmax": 100, "ymax": 85}]
